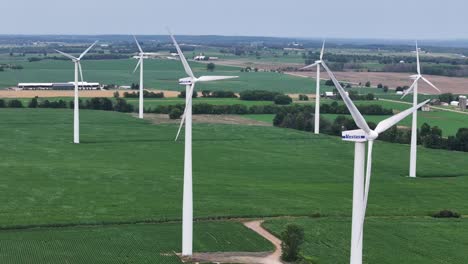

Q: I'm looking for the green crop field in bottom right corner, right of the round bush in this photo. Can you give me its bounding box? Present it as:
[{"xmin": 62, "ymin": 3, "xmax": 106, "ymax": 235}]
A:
[{"xmin": 264, "ymin": 217, "xmax": 468, "ymax": 264}]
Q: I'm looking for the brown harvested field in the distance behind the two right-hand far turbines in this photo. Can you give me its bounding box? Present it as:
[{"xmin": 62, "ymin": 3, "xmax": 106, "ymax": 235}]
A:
[{"xmin": 287, "ymin": 71, "xmax": 468, "ymax": 94}]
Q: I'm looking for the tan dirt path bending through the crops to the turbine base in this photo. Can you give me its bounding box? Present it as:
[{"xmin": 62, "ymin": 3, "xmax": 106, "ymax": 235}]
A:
[{"xmin": 186, "ymin": 220, "xmax": 283, "ymax": 264}]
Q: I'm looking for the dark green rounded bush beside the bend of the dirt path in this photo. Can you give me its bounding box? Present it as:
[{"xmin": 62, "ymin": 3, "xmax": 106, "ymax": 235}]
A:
[{"xmin": 281, "ymin": 224, "xmax": 304, "ymax": 261}]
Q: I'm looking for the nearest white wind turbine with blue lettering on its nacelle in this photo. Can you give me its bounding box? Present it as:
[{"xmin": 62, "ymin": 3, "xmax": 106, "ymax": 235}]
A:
[{"xmin": 322, "ymin": 62, "xmax": 429, "ymax": 264}]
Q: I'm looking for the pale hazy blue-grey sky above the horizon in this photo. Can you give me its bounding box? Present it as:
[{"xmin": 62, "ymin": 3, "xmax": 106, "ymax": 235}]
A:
[{"xmin": 0, "ymin": 0, "xmax": 468, "ymax": 39}]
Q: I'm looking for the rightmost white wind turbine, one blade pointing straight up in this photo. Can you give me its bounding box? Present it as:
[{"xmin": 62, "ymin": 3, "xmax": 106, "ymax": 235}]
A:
[{"xmin": 401, "ymin": 42, "xmax": 440, "ymax": 178}]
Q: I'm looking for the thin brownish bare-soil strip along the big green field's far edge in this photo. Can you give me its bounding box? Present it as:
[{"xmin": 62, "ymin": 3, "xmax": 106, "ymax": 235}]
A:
[{"xmin": 140, "ymin": 114, "xmax": 272, "ymax": 126}]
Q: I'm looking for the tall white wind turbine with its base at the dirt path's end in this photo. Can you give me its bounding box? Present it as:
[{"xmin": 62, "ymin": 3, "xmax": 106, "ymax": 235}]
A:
[{"xmin": 169, "ymin": 32, "xmax": 238, "ymax": 256}]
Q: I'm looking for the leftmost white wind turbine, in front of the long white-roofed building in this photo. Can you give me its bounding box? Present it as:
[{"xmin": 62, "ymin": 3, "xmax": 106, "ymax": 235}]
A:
[{"xmin": 55, "ymin": 41, "xmax": 97, "ymax": 144}]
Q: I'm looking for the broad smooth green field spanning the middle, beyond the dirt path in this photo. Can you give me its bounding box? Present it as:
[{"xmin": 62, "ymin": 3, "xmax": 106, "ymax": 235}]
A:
[{"xmin": 0, "ymin": 109, "xmax": 468, "ymax": 226}]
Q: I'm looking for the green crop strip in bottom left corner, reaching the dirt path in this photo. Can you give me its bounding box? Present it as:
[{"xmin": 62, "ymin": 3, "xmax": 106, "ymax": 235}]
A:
[{"xmin": 0, "ymin": 222, "xmax": 273, "ymax": 264}]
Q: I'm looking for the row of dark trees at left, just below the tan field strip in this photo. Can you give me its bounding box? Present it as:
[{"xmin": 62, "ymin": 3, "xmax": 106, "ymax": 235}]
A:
[{"xmin": 0, "ymin": 97, "xmax": 134, "ymax": 112}]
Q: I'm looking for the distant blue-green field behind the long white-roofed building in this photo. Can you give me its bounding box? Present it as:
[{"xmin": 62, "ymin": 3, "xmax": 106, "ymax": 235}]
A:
[{"xmin": 0, "ymin": 56, "xmax": 332, "ymax": 93}]
